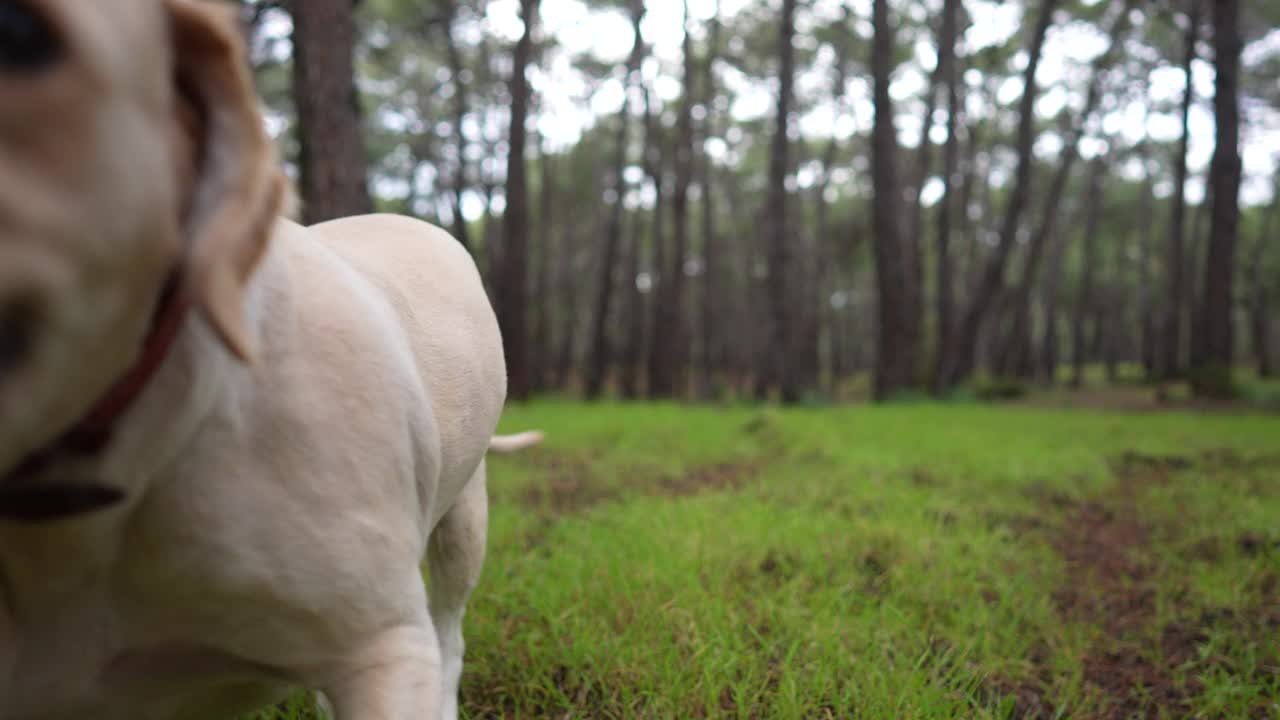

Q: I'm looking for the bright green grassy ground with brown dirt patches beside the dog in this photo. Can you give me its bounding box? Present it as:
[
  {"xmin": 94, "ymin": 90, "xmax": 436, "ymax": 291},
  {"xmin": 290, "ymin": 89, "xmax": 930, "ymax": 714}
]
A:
[{"xmin": 252, "ymin": 402, "xmax": 1280, "ymax": 719}]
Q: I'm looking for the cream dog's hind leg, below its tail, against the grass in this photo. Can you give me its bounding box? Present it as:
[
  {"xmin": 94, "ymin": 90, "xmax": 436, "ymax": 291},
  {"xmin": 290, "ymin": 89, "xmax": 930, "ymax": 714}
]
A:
[{"xmin": 426, "ymin": 461, "xmax": 489, "ymax": 720}]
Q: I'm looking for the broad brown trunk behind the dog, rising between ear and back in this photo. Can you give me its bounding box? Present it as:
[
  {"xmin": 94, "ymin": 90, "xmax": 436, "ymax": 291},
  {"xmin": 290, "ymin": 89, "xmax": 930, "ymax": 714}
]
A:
[{"xmin": 293, "ymin": 0, "xmax": 372, "ymax": 224}]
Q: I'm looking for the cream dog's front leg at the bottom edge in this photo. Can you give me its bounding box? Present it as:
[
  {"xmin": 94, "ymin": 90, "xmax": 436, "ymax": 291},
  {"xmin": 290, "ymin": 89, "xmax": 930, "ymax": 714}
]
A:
[{"xmin": 328, "ymin": 618, "xmax": 442, "ymax": 720}]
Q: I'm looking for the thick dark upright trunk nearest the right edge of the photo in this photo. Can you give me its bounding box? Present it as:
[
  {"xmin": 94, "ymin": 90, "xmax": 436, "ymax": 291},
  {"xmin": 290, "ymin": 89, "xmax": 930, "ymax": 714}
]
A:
[{"xmin": 1194, "ymin": 0, "xmax": 1242, "ymax": 395}]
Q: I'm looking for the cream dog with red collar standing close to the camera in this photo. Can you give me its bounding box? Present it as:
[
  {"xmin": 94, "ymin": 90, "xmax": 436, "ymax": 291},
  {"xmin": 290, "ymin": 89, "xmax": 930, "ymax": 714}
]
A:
[{"xmin": 0, "ymin": 0, "xmax": 538, "ymax": 720}]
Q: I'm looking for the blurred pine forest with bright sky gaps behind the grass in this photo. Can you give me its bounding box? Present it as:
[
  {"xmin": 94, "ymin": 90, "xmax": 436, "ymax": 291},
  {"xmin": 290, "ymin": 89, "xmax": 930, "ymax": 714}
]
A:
[{"xmin": 244, "ymin": 0, "xmax": 1280, "ymax": 402}]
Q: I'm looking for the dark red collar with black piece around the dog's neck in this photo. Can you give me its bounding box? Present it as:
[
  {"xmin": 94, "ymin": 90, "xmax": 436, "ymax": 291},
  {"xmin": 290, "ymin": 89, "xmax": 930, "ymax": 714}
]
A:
[{"xmin": 0, "ymin": 272, "xmax": 191, "ymax": 523}]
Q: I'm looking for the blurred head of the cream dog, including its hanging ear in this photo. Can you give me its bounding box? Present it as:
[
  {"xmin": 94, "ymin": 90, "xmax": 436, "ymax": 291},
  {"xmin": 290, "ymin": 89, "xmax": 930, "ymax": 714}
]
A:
[{"xmin": 0, "ymin": 0, "xmax": 285, "ymax": 474}]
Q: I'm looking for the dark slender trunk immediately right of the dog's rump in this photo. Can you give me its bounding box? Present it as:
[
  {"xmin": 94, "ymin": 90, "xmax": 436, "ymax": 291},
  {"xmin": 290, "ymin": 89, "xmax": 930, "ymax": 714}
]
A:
[{"xmin": 497, "ymin": 0, "xmax": 538, "ymax": 401}]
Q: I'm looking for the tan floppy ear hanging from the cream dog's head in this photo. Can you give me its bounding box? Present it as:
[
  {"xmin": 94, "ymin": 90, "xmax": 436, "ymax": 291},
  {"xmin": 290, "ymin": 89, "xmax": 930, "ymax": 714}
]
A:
[{"xmin": 165, "ymin": 0, "xmax": 288, "ymax": 361}]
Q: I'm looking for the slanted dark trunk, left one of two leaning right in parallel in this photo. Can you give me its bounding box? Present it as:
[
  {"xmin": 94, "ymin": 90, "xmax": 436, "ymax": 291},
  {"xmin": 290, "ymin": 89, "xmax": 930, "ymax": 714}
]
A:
[{"xmin": 940, "ymin": 0, "xmax": 1059, "ymax": 389}]
